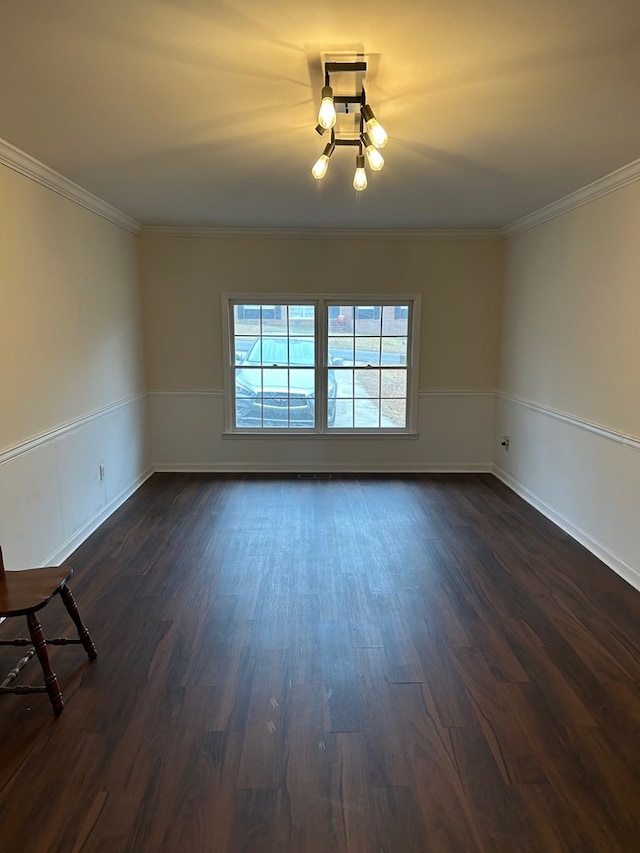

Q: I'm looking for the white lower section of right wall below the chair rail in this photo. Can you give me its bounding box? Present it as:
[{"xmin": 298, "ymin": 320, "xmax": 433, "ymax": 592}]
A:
[{"xmin": 495, "ymin": 394, "xmax": 640, "ymax": 590}]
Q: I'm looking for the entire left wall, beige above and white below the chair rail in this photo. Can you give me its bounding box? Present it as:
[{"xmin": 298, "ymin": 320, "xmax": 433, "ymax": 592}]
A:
[{"xmin": 0, "ymin": 166, "xmax": 150, "ymax": 568}]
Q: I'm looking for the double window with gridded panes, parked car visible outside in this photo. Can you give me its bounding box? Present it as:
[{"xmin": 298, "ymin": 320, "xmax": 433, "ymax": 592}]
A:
[{"xmin": 224, "ymin": 295, "xmax": 419, "ymax": 434}]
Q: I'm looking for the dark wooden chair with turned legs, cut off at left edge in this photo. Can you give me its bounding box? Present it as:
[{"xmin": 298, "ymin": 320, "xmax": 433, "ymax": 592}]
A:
[{"xmin": 0, "ymin": 548, "xmax": 97, "ymax": 714}]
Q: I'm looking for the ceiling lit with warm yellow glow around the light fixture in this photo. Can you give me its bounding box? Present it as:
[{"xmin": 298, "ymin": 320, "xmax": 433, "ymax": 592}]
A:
[{"xmin": 0, "ymin": 0, "xmax": 640, "ymax": 229}]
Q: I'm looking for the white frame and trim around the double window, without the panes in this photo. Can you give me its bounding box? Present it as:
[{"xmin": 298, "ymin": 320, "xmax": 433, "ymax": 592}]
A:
[{"xmin": 221, "ymin": 293, "xmax": 422, "ymax": 439}]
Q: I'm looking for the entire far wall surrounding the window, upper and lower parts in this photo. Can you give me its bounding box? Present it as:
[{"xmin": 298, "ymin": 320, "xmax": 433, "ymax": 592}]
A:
[{"xmin": 139, "ymin": 236, "xmax": 503, "ymax": 472}]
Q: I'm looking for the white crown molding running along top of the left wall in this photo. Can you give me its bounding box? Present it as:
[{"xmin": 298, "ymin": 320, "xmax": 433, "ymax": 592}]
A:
[{"xmin": 0, "ymin": 139, "xmax": 140, "ymax": 234}]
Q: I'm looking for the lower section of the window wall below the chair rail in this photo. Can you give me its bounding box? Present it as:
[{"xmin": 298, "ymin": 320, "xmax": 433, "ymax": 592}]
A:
[{"xmin": 149, "ymin": 391, "xmax": 495, "ymax": 472}]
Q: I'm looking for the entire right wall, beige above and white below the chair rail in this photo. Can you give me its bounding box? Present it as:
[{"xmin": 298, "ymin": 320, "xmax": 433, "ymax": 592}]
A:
[{"xmin": 496, "ymin": 182, "xmax": 640, "ymax": 589}]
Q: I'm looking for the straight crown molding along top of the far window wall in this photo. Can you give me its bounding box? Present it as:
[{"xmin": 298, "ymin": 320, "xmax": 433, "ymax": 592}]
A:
[{"xmin": 140, "ymin": 225, "xmax": 503, "ymax": 240}]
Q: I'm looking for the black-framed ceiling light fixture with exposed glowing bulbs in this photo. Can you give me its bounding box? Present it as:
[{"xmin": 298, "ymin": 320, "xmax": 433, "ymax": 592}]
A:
[{"xmin": 311, "ymin": 61, "xmax": 389, "ymax": 192}]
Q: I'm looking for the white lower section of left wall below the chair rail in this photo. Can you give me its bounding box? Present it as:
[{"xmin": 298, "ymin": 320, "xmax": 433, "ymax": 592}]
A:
[{"xmin": 0, "ymin": 394, "xmax": 151, "ymax": 569}]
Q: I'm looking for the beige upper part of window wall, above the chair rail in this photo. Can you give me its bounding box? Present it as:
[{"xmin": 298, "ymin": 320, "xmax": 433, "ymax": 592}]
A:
[{"xmin": 139, "ymin": 236, "xmax": 503, "ymax": 391}]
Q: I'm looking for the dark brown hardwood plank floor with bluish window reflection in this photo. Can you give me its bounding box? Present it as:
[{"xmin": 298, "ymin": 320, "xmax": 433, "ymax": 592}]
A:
[{"xmin": 0, "ymin": 474, "xmax": 640, "ymax": 853}]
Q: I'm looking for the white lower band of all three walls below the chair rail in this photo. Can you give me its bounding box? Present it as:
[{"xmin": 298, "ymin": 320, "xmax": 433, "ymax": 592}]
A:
[{"xmin": 6, "ymin": 382, "xmax": 640, "ymax": 589}]
